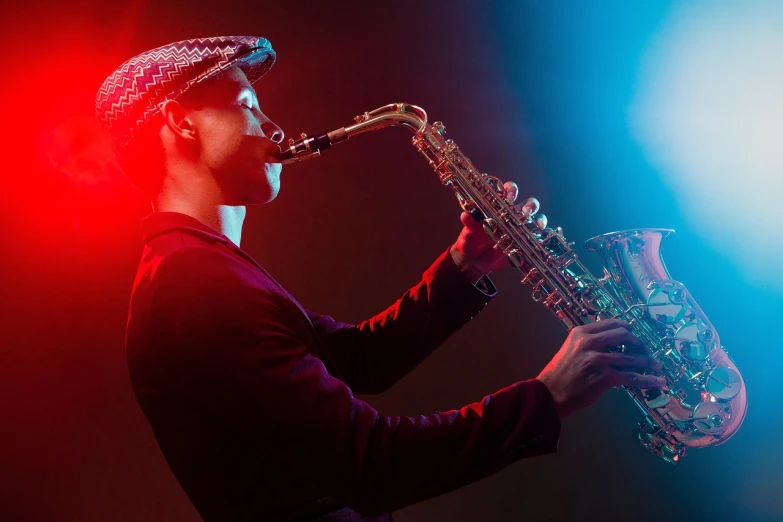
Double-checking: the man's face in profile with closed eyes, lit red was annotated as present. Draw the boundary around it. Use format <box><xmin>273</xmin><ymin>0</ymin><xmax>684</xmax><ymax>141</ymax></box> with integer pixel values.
<box><xmin>188</xmin><ymin>67</ymin><xmax>283</xmax><ymax>205</ymax></box>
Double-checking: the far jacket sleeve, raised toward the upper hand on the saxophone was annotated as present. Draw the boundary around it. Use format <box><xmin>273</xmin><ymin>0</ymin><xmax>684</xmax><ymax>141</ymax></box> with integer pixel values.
<box><xmin>308</xmin><ymin>250</ymin><xmax>497</xmax><ymax>394</ymax></box>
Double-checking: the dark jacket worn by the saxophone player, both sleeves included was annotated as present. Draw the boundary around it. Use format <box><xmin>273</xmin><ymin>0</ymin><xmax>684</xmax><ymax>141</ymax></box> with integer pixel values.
<box><xmin>126</xmin><ymin>213</ymin><xmax>560</xmax><ymax>522</ymax></box>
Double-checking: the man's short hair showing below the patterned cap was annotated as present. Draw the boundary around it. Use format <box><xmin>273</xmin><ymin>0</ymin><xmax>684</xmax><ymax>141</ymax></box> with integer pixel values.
<box><xmin>117</xmin><ymin>80</ymin><xmax>219</xmax><ymax>198</ymax></box>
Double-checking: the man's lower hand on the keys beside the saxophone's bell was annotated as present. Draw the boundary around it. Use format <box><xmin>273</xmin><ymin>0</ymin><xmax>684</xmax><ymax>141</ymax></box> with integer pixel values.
<box><xmin>537</xmin><ymin>319</ymin><xmax>666</xmax><ymax>418</ymax></box>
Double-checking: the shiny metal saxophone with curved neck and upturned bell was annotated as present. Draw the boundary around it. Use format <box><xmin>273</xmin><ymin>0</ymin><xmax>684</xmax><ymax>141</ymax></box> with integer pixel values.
<box><xmin>280</xmin><ymin>103</ymin><xmax>747</xmax><ymax>463</ymax></box>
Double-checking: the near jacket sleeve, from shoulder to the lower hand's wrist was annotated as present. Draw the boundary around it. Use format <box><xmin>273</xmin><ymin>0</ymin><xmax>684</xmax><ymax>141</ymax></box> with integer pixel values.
<box><xmin>153</xmin><ymin>250</ymin><xmax>560</xmax><ymax>515</ymax></box>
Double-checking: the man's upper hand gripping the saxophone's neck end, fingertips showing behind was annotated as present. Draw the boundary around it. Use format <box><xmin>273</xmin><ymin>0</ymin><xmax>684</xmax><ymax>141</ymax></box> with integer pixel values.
<box><xmin>451</xmin><ymin>181</ymin><xmax>538</xmax><ymax>282</ymax></box>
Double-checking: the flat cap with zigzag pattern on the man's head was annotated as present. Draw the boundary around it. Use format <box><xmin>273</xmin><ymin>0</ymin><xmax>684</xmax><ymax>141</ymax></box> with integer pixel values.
<box><xmin>95</xmin><ymin>36</ymin><xmax>276</xmax><ymax>152</ymax></box>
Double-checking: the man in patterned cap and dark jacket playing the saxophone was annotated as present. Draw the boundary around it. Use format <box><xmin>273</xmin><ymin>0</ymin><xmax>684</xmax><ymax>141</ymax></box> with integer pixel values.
<box><xmin>96</xmin><ymin>37</ymin><xmax>663</xmax><ymax>521</ymax></box>
